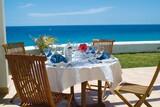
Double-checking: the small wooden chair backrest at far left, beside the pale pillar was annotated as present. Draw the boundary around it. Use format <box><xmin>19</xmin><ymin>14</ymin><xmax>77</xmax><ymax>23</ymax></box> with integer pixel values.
<box><xmin>2</xmin><ymin>42</ymin><xmax>25</xmax><ymax>54</ymax></box>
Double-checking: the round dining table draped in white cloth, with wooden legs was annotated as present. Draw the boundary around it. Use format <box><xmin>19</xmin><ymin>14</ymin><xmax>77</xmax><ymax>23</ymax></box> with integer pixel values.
<box><xmin>46</xmin><ymin>51</ymin><xmax>122</xmax><ymax>107</ymax></box>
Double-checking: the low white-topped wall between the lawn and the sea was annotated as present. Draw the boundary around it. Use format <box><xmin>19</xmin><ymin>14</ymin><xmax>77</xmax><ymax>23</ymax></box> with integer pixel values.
<box><xmin>25</xmin><ymin>41</ymin><xmax>160</xmax><ymax>54</ymax></box>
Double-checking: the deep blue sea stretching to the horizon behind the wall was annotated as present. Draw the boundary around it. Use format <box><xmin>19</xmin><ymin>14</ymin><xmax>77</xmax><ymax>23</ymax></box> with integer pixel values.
<box><xmin>6</xmin><ymin>25</ymin><xmax>160</xmax><ymax>46</ymax></box>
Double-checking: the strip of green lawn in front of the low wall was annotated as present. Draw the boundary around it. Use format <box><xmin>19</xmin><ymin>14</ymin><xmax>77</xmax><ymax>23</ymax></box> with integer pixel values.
<box><xmin>114</xmin><ymin>52</ymin><xmax>160</xmax><ymax>68</ymax></box>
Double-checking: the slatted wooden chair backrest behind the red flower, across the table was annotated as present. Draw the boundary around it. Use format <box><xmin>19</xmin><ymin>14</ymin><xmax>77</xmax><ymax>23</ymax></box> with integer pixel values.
<box><xmin>93</xmin><ymin>39</ymin><xmax>114</xmax><ymax>54</ymax></box>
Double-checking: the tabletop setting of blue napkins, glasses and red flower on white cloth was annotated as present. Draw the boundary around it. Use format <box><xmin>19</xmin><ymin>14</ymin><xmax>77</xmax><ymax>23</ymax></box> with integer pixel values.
<box><xmin>44</xmin><ymin>44</ymin><xmax>117</xmax><ymax>67</ymax></box>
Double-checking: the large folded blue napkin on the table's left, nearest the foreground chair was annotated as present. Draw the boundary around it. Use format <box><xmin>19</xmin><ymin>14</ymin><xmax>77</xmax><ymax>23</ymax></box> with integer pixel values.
<box><xmin>50</xmin><ymin>53</ymin><xmax>67</xmax><ymax>63</ymax></box>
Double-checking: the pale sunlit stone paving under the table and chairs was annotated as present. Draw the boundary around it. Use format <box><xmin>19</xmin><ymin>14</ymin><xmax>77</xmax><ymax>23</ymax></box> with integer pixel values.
<box><xmin>0</xmin><ymin>67</ymin><xmax>160</xmax><ymax>107</ymax></box>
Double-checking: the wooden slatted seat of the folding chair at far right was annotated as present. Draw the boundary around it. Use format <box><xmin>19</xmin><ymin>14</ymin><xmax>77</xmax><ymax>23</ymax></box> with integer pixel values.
<box><xmin>115</xmin><ymin>83</ymin><xmax>152</xmax><ymax>96</ymax></box>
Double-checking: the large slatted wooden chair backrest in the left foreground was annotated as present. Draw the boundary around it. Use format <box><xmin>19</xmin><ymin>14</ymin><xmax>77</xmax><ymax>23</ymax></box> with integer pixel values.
<box><xmin>6</xmin><ymin>54</ymin><xmax>55</xmax><ymax>107</ymax></box>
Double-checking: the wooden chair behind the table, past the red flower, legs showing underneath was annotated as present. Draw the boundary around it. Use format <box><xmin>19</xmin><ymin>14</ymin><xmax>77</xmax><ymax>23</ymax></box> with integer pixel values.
<box><xmin>87</xmin><ymin>39</ymin><xmax>114</xmax><ymax>98</ymax></box>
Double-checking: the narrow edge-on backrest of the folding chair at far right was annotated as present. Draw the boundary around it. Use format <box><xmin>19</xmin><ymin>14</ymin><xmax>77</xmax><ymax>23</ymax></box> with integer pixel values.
<box><xmin>146</xmin><ymin>61</ymin><xmax>160</xmax><ymax>94</ymax></box>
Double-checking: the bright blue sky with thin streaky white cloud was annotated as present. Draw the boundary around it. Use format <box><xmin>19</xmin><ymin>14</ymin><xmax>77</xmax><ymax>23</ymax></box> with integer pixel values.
<box><xmin>4</xmin><ymin>0</ymin><xmax>160</xmax><ymax>26</ymax></box>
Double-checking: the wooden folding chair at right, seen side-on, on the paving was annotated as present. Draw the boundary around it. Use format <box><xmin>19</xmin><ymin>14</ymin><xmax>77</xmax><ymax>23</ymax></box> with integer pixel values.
<box><xmin>114</xmin><ymin>62</ymin><xmax>160</xmax><ymax>107</ymax></box>
